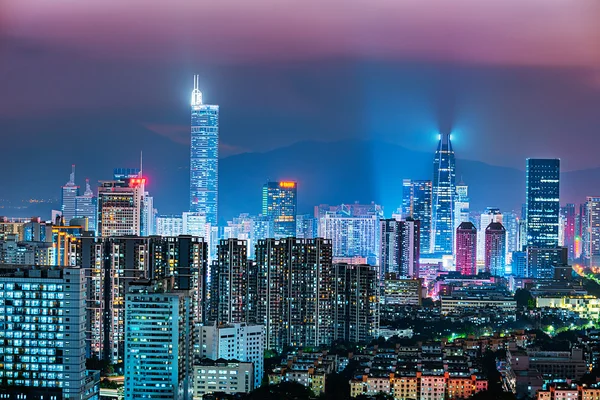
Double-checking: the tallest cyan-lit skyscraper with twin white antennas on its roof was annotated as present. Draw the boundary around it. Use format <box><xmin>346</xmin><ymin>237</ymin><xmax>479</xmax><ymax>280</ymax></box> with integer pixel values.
<box><xmin>190</xmin><ymin>75</ymin><xmax>219</xmax><ymax>226</ymax></box>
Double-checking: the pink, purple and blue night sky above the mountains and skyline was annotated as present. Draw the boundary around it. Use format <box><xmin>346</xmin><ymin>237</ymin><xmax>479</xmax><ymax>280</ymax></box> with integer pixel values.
<box><xmin>0</xmin><ymin>0</ymin><xmax>600</xmax><ymax>216</ymax></box>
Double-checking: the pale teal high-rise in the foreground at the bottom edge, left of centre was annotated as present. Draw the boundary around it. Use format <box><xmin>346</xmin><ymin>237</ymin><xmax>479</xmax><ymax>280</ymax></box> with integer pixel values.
<box><xmin>125</xmin><ymin>278</ymin><xmax>194</xmax><ymax>400</ymax></box>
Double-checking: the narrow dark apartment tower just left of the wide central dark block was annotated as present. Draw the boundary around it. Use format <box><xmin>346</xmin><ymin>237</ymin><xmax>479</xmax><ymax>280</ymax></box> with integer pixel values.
<box><xmin>207</xmin><ymin>239</ymin><xmax>250</xmax><ymax>324</ymax></box>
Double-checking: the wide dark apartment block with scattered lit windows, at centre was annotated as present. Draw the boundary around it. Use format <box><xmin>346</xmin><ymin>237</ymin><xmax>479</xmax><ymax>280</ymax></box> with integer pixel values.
<box><xmin>252</xmin><ymin>238</ymin><xmax>332</xmax><ymax>352</ymax></box>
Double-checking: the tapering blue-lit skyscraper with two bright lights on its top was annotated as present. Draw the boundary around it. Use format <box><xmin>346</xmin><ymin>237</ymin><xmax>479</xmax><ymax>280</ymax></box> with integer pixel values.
<box><xmin>431</xmin><ymin>133</ymin><xmax>456</xmax><ymax>254</ymax></box>
